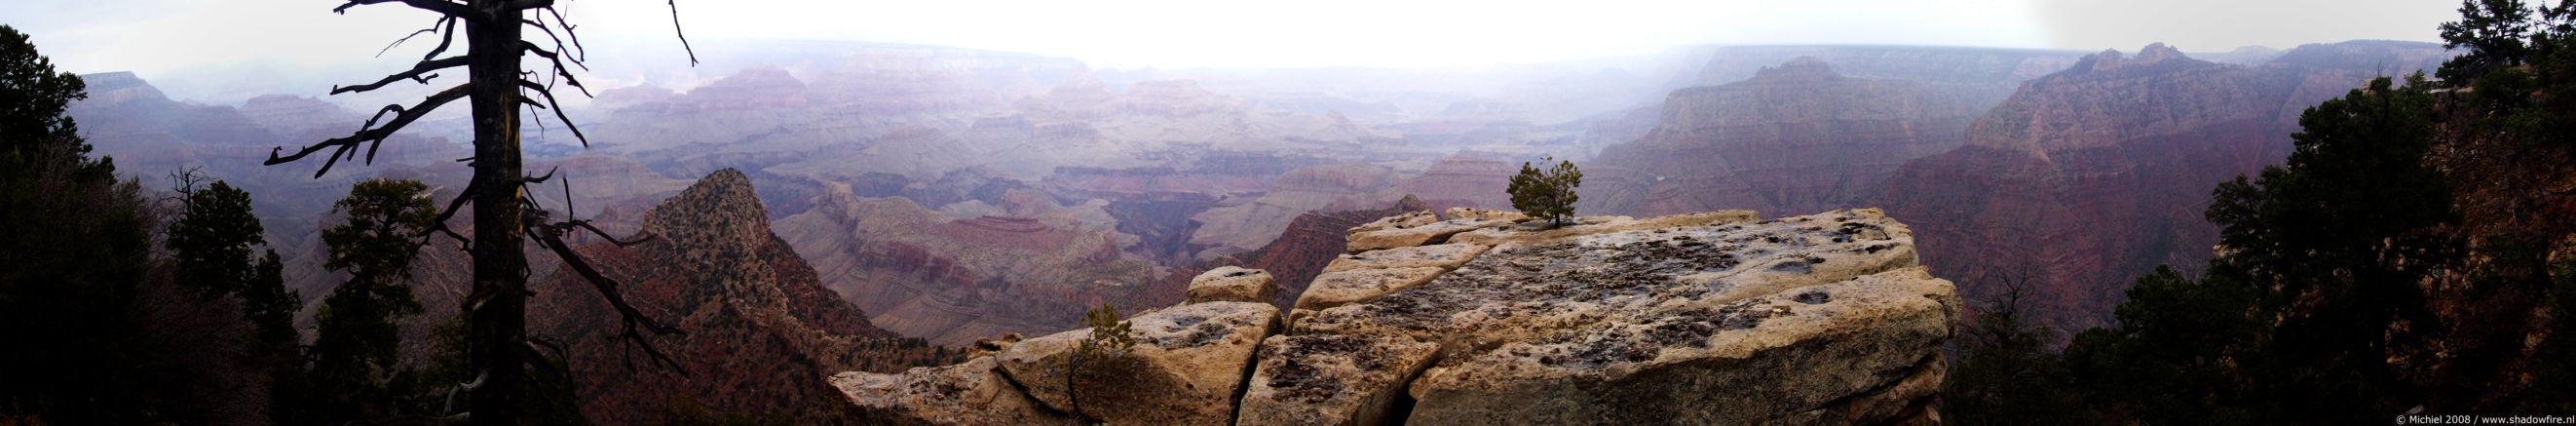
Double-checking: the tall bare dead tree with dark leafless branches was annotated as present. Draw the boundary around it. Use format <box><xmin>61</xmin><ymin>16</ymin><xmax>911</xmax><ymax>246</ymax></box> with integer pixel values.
<box><xmin>268</xmin><ymin>0</ymin><xmax>699</xmax><ymax>423</ymax></box>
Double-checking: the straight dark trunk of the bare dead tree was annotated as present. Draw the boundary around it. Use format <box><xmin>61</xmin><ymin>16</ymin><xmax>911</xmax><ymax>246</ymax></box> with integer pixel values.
<box><xmin>464</xmin><ymin>0</ymin><xmax>528</xmax><ymax>423</ymax></box>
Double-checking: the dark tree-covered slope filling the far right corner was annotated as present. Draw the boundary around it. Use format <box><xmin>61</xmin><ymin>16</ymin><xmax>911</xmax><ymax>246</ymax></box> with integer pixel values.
<box><xmin>1945</xmin><ymin>0</ymin><xmax>2576</xmax><ymax>423</ymax></box>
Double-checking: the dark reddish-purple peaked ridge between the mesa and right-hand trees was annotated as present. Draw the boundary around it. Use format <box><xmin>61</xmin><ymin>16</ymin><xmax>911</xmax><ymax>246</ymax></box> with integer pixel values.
<box><xmin>1868</xmin><ymin>41</ymin><xmax>2443</xmax><ymax>330</ymax></box>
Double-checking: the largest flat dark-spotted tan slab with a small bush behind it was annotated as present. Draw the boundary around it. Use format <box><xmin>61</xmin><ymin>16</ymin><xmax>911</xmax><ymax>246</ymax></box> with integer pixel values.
<box><xmin>1298</xmin><ymin>210</ymin><xmax>1957</xmax><ymax>423</ymax></box>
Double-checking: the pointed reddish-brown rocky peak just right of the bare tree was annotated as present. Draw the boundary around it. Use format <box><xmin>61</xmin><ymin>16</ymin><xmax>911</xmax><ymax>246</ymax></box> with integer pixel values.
<box><xmin>528</xmin><ymin>171</ymin><xmax>956</xmax><ymax>423</ymax></box>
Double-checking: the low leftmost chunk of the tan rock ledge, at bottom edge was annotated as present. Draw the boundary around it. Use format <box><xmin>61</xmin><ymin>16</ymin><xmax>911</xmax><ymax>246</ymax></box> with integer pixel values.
<box><xmin>832</xmin><ymin>356</ymin><xmax>1067</xmax><ymax>423</ymax></box>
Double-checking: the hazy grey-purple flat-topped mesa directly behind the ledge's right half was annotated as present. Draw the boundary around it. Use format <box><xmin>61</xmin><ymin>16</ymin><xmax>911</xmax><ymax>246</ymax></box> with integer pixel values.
<box><xmin>1581</xmin><ymin>57</ymin><xmax>2009</xmax><ymax>214</ymax></box>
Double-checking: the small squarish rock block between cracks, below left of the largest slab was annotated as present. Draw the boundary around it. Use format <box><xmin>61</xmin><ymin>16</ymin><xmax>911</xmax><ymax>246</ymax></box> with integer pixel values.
<box><xmin>1236</xmin><ymin>335</ymin><xmax>1440</xmax><ymax>426</ymax></box>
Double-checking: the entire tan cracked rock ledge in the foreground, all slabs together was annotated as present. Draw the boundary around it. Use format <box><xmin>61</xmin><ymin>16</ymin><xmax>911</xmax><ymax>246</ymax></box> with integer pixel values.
<box><xmin>832</xmin><ymin>210</ymin><xmax>1960</xmax><ymax>423</ymax></box>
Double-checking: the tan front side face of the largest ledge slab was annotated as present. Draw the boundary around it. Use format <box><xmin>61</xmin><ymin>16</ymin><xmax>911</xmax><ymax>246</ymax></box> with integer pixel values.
<box><xmin>1412</xmin><ymin>268</ymin><xmax>1957</xmax><ymax>423</ymax></box>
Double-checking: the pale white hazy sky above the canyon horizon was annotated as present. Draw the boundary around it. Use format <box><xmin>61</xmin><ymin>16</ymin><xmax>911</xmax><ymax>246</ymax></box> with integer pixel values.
<box><xmin>0</xmin><ymin>0</ymin><xmax>2457</xmax><ymax>77</ymax></box>
